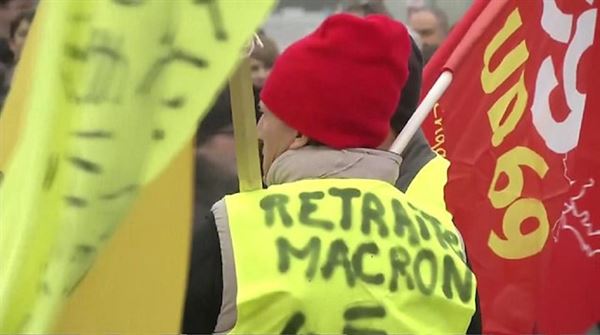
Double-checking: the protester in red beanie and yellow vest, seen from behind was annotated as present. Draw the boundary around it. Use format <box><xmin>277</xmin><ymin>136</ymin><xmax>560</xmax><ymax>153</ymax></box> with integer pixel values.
<box><xmin>182</xmin><ymin>14</ymin><xmax>475</xmax><ymax>333</ymax></box>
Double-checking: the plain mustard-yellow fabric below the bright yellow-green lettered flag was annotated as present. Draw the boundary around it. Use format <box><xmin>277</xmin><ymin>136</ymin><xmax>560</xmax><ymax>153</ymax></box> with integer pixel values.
<box><xmin>55</xmin><ymin>145</ymin><xmax>194</xmax><ymax>335</ymax></box>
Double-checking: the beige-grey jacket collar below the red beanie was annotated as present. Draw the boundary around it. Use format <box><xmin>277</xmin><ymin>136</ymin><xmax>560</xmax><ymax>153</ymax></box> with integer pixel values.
<box><xmin>265</xmin><ymin>145</ymin><xmax>402</xmax><ymax>186</ymax></box>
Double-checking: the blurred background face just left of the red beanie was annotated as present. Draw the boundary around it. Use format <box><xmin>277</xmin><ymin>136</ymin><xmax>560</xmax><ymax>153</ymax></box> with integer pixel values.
<box><xmin>250</xmin><ymin>30</ymin><xmax>279</xmax><ymax>91</ymax></box>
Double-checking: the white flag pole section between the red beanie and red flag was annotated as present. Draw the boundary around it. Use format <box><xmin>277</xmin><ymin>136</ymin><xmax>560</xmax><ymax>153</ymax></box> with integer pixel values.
<box><xmin>389</xmin><ymin>71</ymin><xmax>452</xmax><ymax>155</ymax></box>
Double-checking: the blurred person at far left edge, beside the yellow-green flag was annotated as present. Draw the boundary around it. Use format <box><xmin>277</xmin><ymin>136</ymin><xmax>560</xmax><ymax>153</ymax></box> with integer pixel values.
<box><xmin>0</xmin><ymin>11</ymin><xmax>35</xmax><ymax>105</ymax></box>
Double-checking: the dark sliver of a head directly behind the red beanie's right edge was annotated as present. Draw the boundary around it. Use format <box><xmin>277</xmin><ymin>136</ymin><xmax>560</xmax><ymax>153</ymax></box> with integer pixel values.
<box><xmin>390</xmin><ymin>37</ymin><xmax>423</xmax><ymax>133</ymax></box>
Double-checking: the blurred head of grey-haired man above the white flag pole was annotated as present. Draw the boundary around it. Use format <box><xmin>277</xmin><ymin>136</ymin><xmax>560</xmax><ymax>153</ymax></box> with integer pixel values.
<box><xmin>408</xmin><ymin>7</ymin><xmax>449</xmax><ymax>64</ymax></box>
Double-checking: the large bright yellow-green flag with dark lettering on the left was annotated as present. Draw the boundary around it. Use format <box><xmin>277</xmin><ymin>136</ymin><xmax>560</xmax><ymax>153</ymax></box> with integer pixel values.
<box><xmin>0</xmin><ymin>0</ymin><xmax>273</xmax><ymax>333</ymax></box>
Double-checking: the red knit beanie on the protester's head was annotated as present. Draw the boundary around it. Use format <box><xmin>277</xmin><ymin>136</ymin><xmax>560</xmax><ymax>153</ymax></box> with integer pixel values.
<box><xmin>261</xmin><ymin>14</ymin><xmax>411</xmax><ymax>149</ymax></box>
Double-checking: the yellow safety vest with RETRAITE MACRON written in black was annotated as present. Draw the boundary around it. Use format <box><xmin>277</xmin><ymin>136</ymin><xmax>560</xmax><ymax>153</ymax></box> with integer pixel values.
<box><xmin>225</xmin><ymin>179</ymin><xmax>476</xmax><ymax>334</ymax></box>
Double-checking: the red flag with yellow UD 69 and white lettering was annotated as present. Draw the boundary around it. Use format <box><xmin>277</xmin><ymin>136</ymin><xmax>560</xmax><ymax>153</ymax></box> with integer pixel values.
<box><xmin>423</xmin><ymin>0</ymin><xmax>600</xmax><ymax>334</ymax></box>
